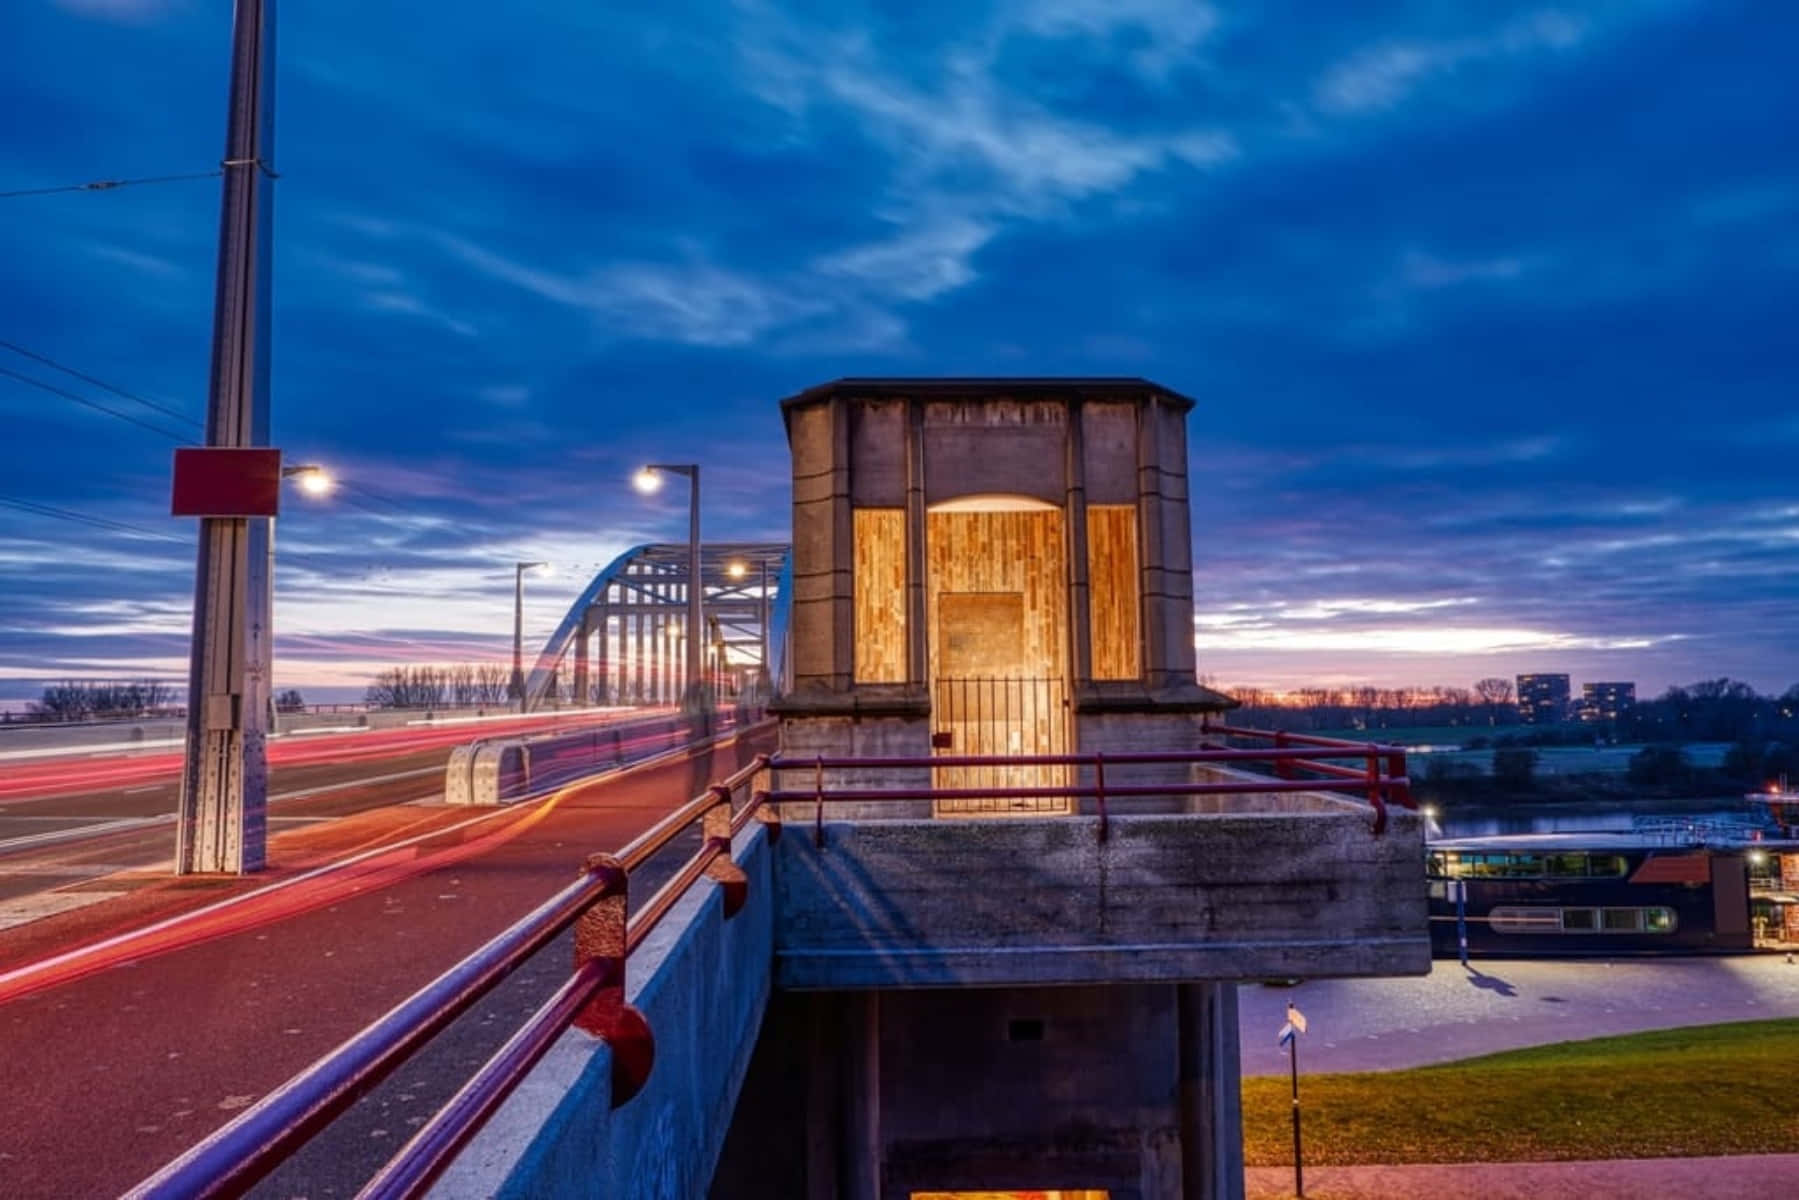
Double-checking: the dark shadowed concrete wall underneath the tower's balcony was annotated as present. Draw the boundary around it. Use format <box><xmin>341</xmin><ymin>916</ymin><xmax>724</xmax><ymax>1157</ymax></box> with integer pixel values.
<box><xmin>712</xmin><ymin>984</ymin><xmax>1243</xmax><ymax>1200</ymax></box>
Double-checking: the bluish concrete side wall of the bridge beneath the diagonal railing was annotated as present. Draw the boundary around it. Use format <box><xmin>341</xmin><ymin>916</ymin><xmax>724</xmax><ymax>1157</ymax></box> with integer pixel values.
<box><xmin>430</xmin><ymin>824</ymin><xmax>774</xmax><ymax>1200</ymax></box>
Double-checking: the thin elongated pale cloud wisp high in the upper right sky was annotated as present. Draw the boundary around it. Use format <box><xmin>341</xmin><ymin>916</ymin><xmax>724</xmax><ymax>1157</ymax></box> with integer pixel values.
<box><xmin>1311</xmin><ymin>9</ymin><xmax>1589</xmax><ymax>117</ymax></box>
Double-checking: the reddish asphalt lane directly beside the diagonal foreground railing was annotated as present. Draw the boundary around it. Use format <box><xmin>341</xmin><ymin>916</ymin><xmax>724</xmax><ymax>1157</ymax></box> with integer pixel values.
<box><xmin>0</xmin><ymin>734</ymin><xmax>772</xmax><ymax>1196</ymax></box>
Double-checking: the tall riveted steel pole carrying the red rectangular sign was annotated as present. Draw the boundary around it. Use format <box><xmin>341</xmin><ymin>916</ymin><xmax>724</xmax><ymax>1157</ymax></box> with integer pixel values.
<box><xmin>175</xmin><ymin>0</ymin><xmax>279</xmax><ymax>874</ymax></box>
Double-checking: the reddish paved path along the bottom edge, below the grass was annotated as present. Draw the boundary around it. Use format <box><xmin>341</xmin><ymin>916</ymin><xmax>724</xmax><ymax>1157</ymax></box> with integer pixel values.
<box><xmin>1247</xmin><ymin>1155</ymin><xmax>1799</xmax><ymax>1200</ymax></box>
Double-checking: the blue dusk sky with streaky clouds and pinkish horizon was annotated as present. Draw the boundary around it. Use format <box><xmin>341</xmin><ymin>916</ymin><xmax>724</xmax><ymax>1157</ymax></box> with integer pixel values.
<box><xmin>0</xmin><ymin>0</ymin><xmax>1799</xmax><ymax>698</ymax></box>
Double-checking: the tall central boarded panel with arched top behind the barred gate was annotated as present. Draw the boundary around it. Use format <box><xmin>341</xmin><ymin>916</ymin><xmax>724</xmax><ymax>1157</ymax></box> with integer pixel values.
<box><xmin>925</xmin><ymin>509</ymin><xmax>1072</xmax><ymax>815</ymax></box>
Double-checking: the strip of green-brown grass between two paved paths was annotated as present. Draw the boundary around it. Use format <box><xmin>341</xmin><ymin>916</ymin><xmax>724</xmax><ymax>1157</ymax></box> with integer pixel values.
<box><xmin>1243</xmin><ymin>1020</ymin><xmax>1799</xmax><ymax>1166</ymax></box>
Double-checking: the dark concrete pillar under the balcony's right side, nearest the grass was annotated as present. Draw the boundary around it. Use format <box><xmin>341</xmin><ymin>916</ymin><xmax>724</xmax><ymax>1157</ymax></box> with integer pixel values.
<box><xmin>1175</xmin><ymin>982</ymin><xmax>1243</xmax><ymax>1200</ymax></box>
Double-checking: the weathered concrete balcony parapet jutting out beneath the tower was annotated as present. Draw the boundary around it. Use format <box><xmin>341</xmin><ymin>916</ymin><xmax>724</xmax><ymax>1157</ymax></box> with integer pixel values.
<box><xmin>775</xmin><ymin>813</ymin><xmax>1430</xmax><ymax>988</ymax></box>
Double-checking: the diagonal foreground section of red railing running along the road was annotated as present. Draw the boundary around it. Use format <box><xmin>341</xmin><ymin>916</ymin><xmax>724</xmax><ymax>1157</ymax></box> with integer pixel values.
<box><xmin>128</xmin><ymin>723</ymin><xmax>768</xmax><ymax>1200</ymax></box>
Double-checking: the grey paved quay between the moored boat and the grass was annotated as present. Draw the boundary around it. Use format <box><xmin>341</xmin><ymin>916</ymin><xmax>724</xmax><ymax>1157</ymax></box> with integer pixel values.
<box><xmin>1238</xmin><ymin>955</ymin><xmax>1799</xmax><ymax>1079</ymax></box>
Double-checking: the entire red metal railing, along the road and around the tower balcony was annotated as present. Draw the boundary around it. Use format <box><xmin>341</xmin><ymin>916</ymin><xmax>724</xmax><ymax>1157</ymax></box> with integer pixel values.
<box><xmin>128</xmin><ymin>725</ymin><xmax>1416</xmax><ymax>1200</ymax></box>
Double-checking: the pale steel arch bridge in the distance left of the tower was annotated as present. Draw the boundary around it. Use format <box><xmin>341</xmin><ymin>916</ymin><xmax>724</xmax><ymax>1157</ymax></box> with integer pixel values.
<box><xmin>522</xmin><ymin>542</ymin><xmax>793</xmax><ymax>712</ymax></box>
